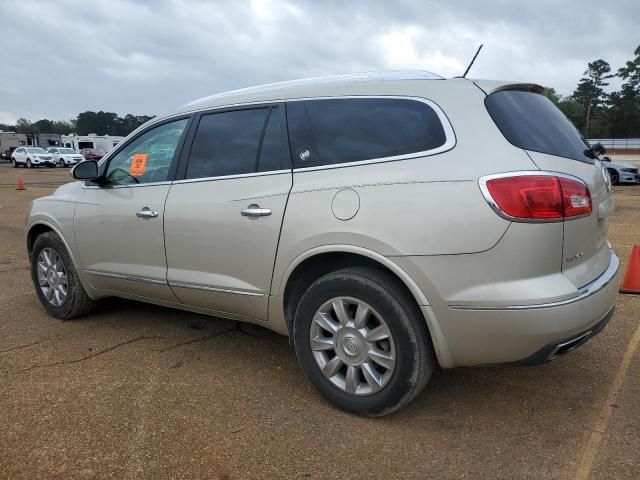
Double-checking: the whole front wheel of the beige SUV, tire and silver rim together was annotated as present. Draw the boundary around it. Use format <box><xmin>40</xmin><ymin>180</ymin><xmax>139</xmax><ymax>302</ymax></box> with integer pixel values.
<box><xmin>31</xmin><ymin>232</ymin><xmax>95</xmax><ymax>320</ymax></box>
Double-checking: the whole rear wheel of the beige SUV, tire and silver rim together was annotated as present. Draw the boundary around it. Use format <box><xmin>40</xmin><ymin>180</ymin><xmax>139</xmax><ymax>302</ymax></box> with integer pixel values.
<box><xmin>293</xmin><ymin>267</ymin><xmax>435</xmax><ymax>417</ymax></box>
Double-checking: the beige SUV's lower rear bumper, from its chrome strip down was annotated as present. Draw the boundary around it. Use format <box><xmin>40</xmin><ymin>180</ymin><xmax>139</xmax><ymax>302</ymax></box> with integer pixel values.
<box><xmin>439</xmin><ymin>252</ymin><xmax>620</xmax><ymax>366</ymax></box>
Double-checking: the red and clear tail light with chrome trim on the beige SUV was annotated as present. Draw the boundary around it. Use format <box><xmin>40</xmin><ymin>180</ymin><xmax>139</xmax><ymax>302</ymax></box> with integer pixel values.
<box><xmin>480</xmin><ymin>172</ymin><xmax>592</xmax><ymax>222</ymax></box>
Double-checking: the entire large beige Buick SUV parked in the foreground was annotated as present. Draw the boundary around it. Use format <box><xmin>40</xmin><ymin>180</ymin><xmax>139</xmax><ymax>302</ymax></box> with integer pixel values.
<box><xmin>27</xmin><ymin>72</ymin><xmax>619</xmax><ymax>416</ymax></box>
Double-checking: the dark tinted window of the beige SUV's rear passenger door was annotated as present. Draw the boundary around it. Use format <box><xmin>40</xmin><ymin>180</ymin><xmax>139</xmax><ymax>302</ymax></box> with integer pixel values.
<box><xmin>186</xmin><ymin>107</ymin><xmax>286</xmax><ymax>179</ymax></box>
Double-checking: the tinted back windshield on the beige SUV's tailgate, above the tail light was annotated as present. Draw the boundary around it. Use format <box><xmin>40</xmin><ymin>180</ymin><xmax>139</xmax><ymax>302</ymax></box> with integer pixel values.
<box><xmin>485</xmin><ymin>90</ymin><xmax>593</xmax><ymax>163</ymax></box>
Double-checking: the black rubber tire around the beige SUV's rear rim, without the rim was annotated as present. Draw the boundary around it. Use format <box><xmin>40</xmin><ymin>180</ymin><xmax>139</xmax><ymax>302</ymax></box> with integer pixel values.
<box><xmin>293</xmin><ymin>267</ymin><xmax>435</xmax><ymax>417</ymax></box>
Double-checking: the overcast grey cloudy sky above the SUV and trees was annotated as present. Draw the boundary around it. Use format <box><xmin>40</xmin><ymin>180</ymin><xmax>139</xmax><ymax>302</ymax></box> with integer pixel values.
<box><xmin>0</xmin><ymin>0</ymin><xmax>640</xmax><ymax>123</ymax></box>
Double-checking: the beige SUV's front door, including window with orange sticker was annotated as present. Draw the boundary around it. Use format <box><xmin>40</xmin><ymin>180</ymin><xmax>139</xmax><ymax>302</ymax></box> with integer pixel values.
<box><xmin>74</xmin><ymin>117</ymin><xmax>190</xmax><ymax>302</ymax></box>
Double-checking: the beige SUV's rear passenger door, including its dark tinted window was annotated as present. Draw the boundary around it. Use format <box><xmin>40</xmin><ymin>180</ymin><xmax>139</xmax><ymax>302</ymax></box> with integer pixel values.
<box><xmin>165</xmin><ymin>104</ymin><xmax>292</xmax><ymax>320</ymax></box>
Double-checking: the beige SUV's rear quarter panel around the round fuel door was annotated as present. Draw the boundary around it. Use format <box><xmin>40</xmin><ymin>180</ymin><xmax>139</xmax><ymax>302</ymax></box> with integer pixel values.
<box><xmin>272</xmin><ymin>80</ymin><xmax>536</xmax><ymax>296</ymax></box>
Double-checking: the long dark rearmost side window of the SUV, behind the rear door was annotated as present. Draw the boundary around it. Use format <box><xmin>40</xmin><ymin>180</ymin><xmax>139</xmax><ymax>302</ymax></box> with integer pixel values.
<box><xmin>287</xmin><ymin>98</ymin><xmax>447</xmax><ymax>168</ymax></box>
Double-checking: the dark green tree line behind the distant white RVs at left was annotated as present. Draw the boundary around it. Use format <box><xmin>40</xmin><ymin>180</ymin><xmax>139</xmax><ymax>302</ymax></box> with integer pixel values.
<box><xmin>0</xmin><ymin>111</ymin><xmax>153</xmax><ymax>137</ymax></box>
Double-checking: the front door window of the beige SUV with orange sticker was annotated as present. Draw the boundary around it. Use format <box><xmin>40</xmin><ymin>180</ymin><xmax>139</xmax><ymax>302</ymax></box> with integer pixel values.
<box><xmin>105</xmin><ymin>118</ymin><xmax>189</xmax><ymax>186</ymax></box>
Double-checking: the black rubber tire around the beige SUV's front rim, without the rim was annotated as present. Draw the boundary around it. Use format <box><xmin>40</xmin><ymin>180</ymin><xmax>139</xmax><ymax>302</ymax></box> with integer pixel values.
<box><xmin>31</xmin><ymin>232</ymin><xmax>95</xmax><ymax>320</ymax></box>
